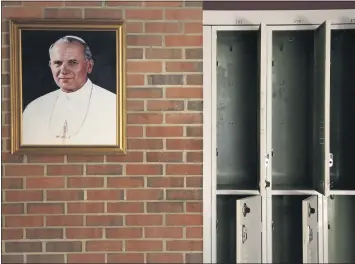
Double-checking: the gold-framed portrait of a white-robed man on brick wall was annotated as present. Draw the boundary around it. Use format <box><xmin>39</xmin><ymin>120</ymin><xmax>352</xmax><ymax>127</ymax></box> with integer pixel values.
<box><xmin>10</xmin><ymin>20</ymin><xmax>126</xmax><ymax>154</ymax></box>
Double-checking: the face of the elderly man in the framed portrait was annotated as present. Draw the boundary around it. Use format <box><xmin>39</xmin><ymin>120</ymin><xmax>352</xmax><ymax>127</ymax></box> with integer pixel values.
<box><xmin>50</xmin><ymin>40</ymin><xmax>93</xmax><ymax>93</ymax></box>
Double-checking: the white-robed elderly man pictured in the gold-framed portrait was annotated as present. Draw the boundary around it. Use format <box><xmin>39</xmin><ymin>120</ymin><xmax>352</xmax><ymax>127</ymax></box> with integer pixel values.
<box><xmin>22</xmin><ymin>36</ymin><xmax>117</xmax><ymax>145</ymax></box>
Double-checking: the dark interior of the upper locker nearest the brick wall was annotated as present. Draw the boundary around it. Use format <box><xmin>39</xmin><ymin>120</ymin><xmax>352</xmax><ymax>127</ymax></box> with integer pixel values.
<box><xmin>217</xmin><ymin>31</ymin><xmax>259</xmax><ymax>189</ymax></box>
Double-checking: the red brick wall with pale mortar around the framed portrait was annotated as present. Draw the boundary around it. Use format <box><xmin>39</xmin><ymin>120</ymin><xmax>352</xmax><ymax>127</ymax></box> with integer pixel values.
<box><xmin>2</xmin><ymin>1</ymin><xmax>202</xmax><ymax>263</ymax></box>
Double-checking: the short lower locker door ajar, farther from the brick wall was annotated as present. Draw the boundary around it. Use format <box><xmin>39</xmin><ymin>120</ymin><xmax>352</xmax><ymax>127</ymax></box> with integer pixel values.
<box><xmin>302</xmin><ymin>196</ymin><xmax>322</xmax><ymax>263</ymax></box>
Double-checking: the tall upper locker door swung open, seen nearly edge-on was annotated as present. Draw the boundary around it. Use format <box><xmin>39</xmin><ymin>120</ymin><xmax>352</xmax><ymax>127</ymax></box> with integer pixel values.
<box><xmin>313</xmin><ymin>21</ymin><xmax>331</xmax><ymax>195</ymax></box>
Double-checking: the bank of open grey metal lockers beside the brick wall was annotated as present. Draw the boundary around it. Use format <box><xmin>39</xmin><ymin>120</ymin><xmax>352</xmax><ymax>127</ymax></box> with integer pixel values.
<box><xmin>204</xmin><ymin>10</ymin><xmax>355</xmax><ymax>263</ymax></box>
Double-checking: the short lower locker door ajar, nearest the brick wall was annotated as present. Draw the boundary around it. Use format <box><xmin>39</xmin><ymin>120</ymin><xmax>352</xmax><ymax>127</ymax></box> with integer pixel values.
<box><xmin>236</xmin><ymin>196</ymin><xmax>262</xmax><ymax>263</ymax></box>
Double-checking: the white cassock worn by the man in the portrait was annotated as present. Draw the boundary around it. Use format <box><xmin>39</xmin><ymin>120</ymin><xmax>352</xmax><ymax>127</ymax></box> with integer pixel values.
<box><xmin>22</xmin><ymin>79</ymin><xmax>117</xmax><ymax>145</ymax></box>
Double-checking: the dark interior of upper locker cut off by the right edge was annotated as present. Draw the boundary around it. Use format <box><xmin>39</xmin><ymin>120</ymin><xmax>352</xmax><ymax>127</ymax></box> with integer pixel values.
<box><xmin>330</xmin><ymin>29</ymin><xmax>355</xmax><ymax>190</ymax></box>
